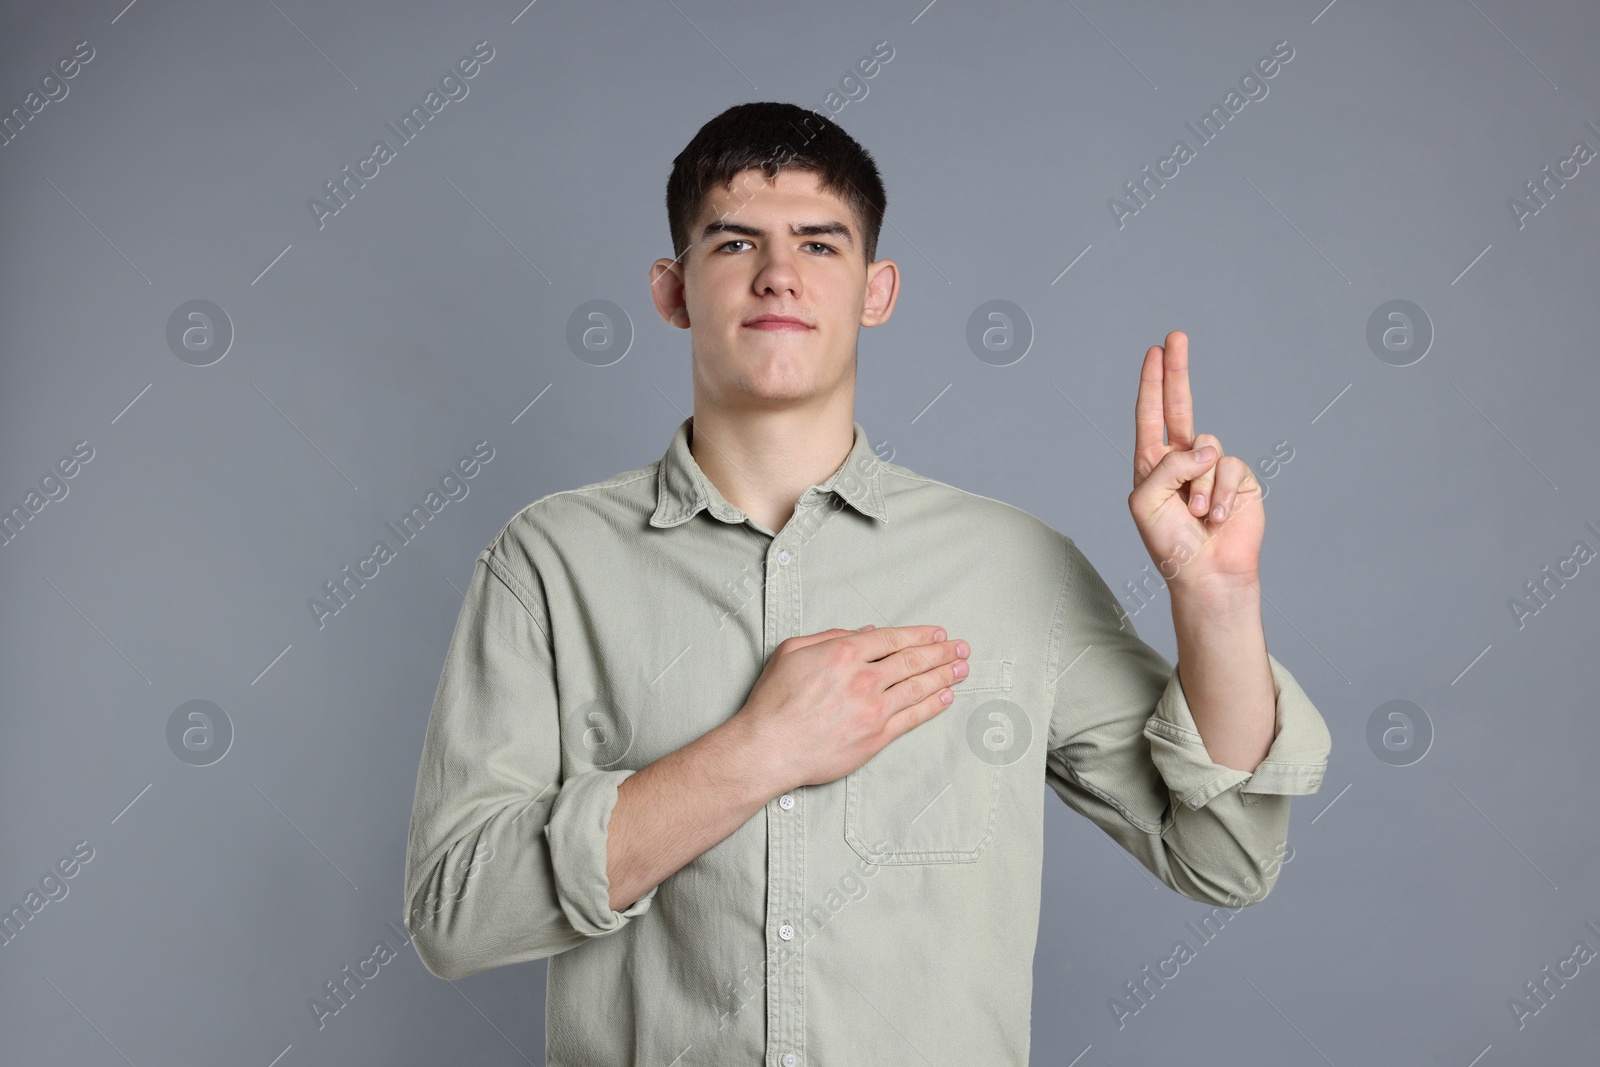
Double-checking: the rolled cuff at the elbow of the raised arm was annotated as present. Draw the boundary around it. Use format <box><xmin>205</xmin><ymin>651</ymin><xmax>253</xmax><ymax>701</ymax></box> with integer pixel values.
<box><xmin>1144</xmin><ymin>653</ymin><xmax>1333</xmax><ymax>808</ymax></box>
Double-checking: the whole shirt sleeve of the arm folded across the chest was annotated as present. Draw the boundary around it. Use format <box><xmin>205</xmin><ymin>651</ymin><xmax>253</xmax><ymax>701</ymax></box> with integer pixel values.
<box><xmin>405</xmin><ymin>545</ymin><xmax>659</xmax><ymax>979</ymax></box>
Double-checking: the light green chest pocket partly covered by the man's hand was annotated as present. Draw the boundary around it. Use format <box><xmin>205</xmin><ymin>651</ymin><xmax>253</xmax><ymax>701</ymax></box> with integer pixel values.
<box><xmin>845</xmin><ymin>659</ymin><xmax>1011</xmax><ymax>864</ymax></box>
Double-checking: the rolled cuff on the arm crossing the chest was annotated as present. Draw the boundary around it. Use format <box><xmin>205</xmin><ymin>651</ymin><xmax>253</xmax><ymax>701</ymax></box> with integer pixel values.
<box><xmin>544</xmin><ymin>769</ymin><xmax>661</xmax><ymax>937</ymax></box>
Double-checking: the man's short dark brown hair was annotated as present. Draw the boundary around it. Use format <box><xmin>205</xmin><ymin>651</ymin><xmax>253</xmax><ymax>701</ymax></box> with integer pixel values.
<box><xmin>667</xmin><ymin>101</ymin><xmax>888</xmax><ymax>262</ymax></box>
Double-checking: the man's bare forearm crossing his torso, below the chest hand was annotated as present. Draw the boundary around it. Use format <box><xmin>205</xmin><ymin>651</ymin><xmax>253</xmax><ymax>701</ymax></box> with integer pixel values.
<box><xmin>606</xmin><ymin>717</ymin><xmax>786</xmax><ymax>910</ymax></box>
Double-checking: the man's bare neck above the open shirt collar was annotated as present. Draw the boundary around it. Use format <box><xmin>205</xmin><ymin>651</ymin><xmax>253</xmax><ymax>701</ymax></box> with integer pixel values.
<box><xmin>690</xmin><ymin>405</ymin><xmax>856</xmax><ymax>533</ymax></box>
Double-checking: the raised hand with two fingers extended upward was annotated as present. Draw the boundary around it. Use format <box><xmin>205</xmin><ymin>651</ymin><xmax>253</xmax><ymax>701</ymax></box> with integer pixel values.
<box><xmin>1128</xmin><ymin>330</ymin><xmax>1267</xmax><ymax>589</ymax></box>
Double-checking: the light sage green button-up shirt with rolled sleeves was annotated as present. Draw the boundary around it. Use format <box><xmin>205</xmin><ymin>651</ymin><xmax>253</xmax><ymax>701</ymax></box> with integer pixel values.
<box><xmin>405</xmin><ymin>416</ymin><xmax>1330</xmax><ymax>1067</ymax></box>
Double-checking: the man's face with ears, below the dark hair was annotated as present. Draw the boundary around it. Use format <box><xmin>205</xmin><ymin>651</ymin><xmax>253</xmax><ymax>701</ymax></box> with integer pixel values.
<box><xmin>651</xmin><ymin>168</ymin><xmax>898</xmax><ymax>408</ymax></box>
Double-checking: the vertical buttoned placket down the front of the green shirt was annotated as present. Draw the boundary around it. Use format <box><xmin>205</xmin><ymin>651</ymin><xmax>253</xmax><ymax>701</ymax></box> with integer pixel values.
<box><xmin>763</xmin><ymin>502</ymin><xmax>806</xmax><ymax>1067</ymax></box>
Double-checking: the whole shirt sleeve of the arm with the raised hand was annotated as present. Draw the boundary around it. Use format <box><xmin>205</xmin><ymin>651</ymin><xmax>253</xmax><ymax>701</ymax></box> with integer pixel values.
<box><xmin>1045</xmin><ymin>537</ymin><xmax>1331</xmax><ymax>907</ymax></box>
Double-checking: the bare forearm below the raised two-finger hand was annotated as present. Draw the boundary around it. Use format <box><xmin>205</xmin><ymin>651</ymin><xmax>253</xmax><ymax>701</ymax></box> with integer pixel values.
<box><xmin>1170</xmin><ymin>582</ymin><xmax>1277</xmax><ymax>771</ymax></box>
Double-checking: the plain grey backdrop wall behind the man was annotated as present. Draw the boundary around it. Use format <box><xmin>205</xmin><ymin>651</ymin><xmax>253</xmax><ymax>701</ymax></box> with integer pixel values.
<box><xmin>0</xmin><ymin>0</ymin><xmax>1600</xmax><ymax>1067</ymax></box>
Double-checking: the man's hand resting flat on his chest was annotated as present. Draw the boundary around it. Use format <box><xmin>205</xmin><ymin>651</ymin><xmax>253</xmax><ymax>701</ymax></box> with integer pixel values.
<box><xmin>730</xmin><ymin>625</ymin><xmax>971</xmax><ymax>789</ymax></box>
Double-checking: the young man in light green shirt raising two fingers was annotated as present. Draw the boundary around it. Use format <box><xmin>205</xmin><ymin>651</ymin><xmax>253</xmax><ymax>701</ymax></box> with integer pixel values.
<box><xmin>405</xmin><ymin>104</ymin><xmax>1330</xmax><ymax>1067</ymax></box>
